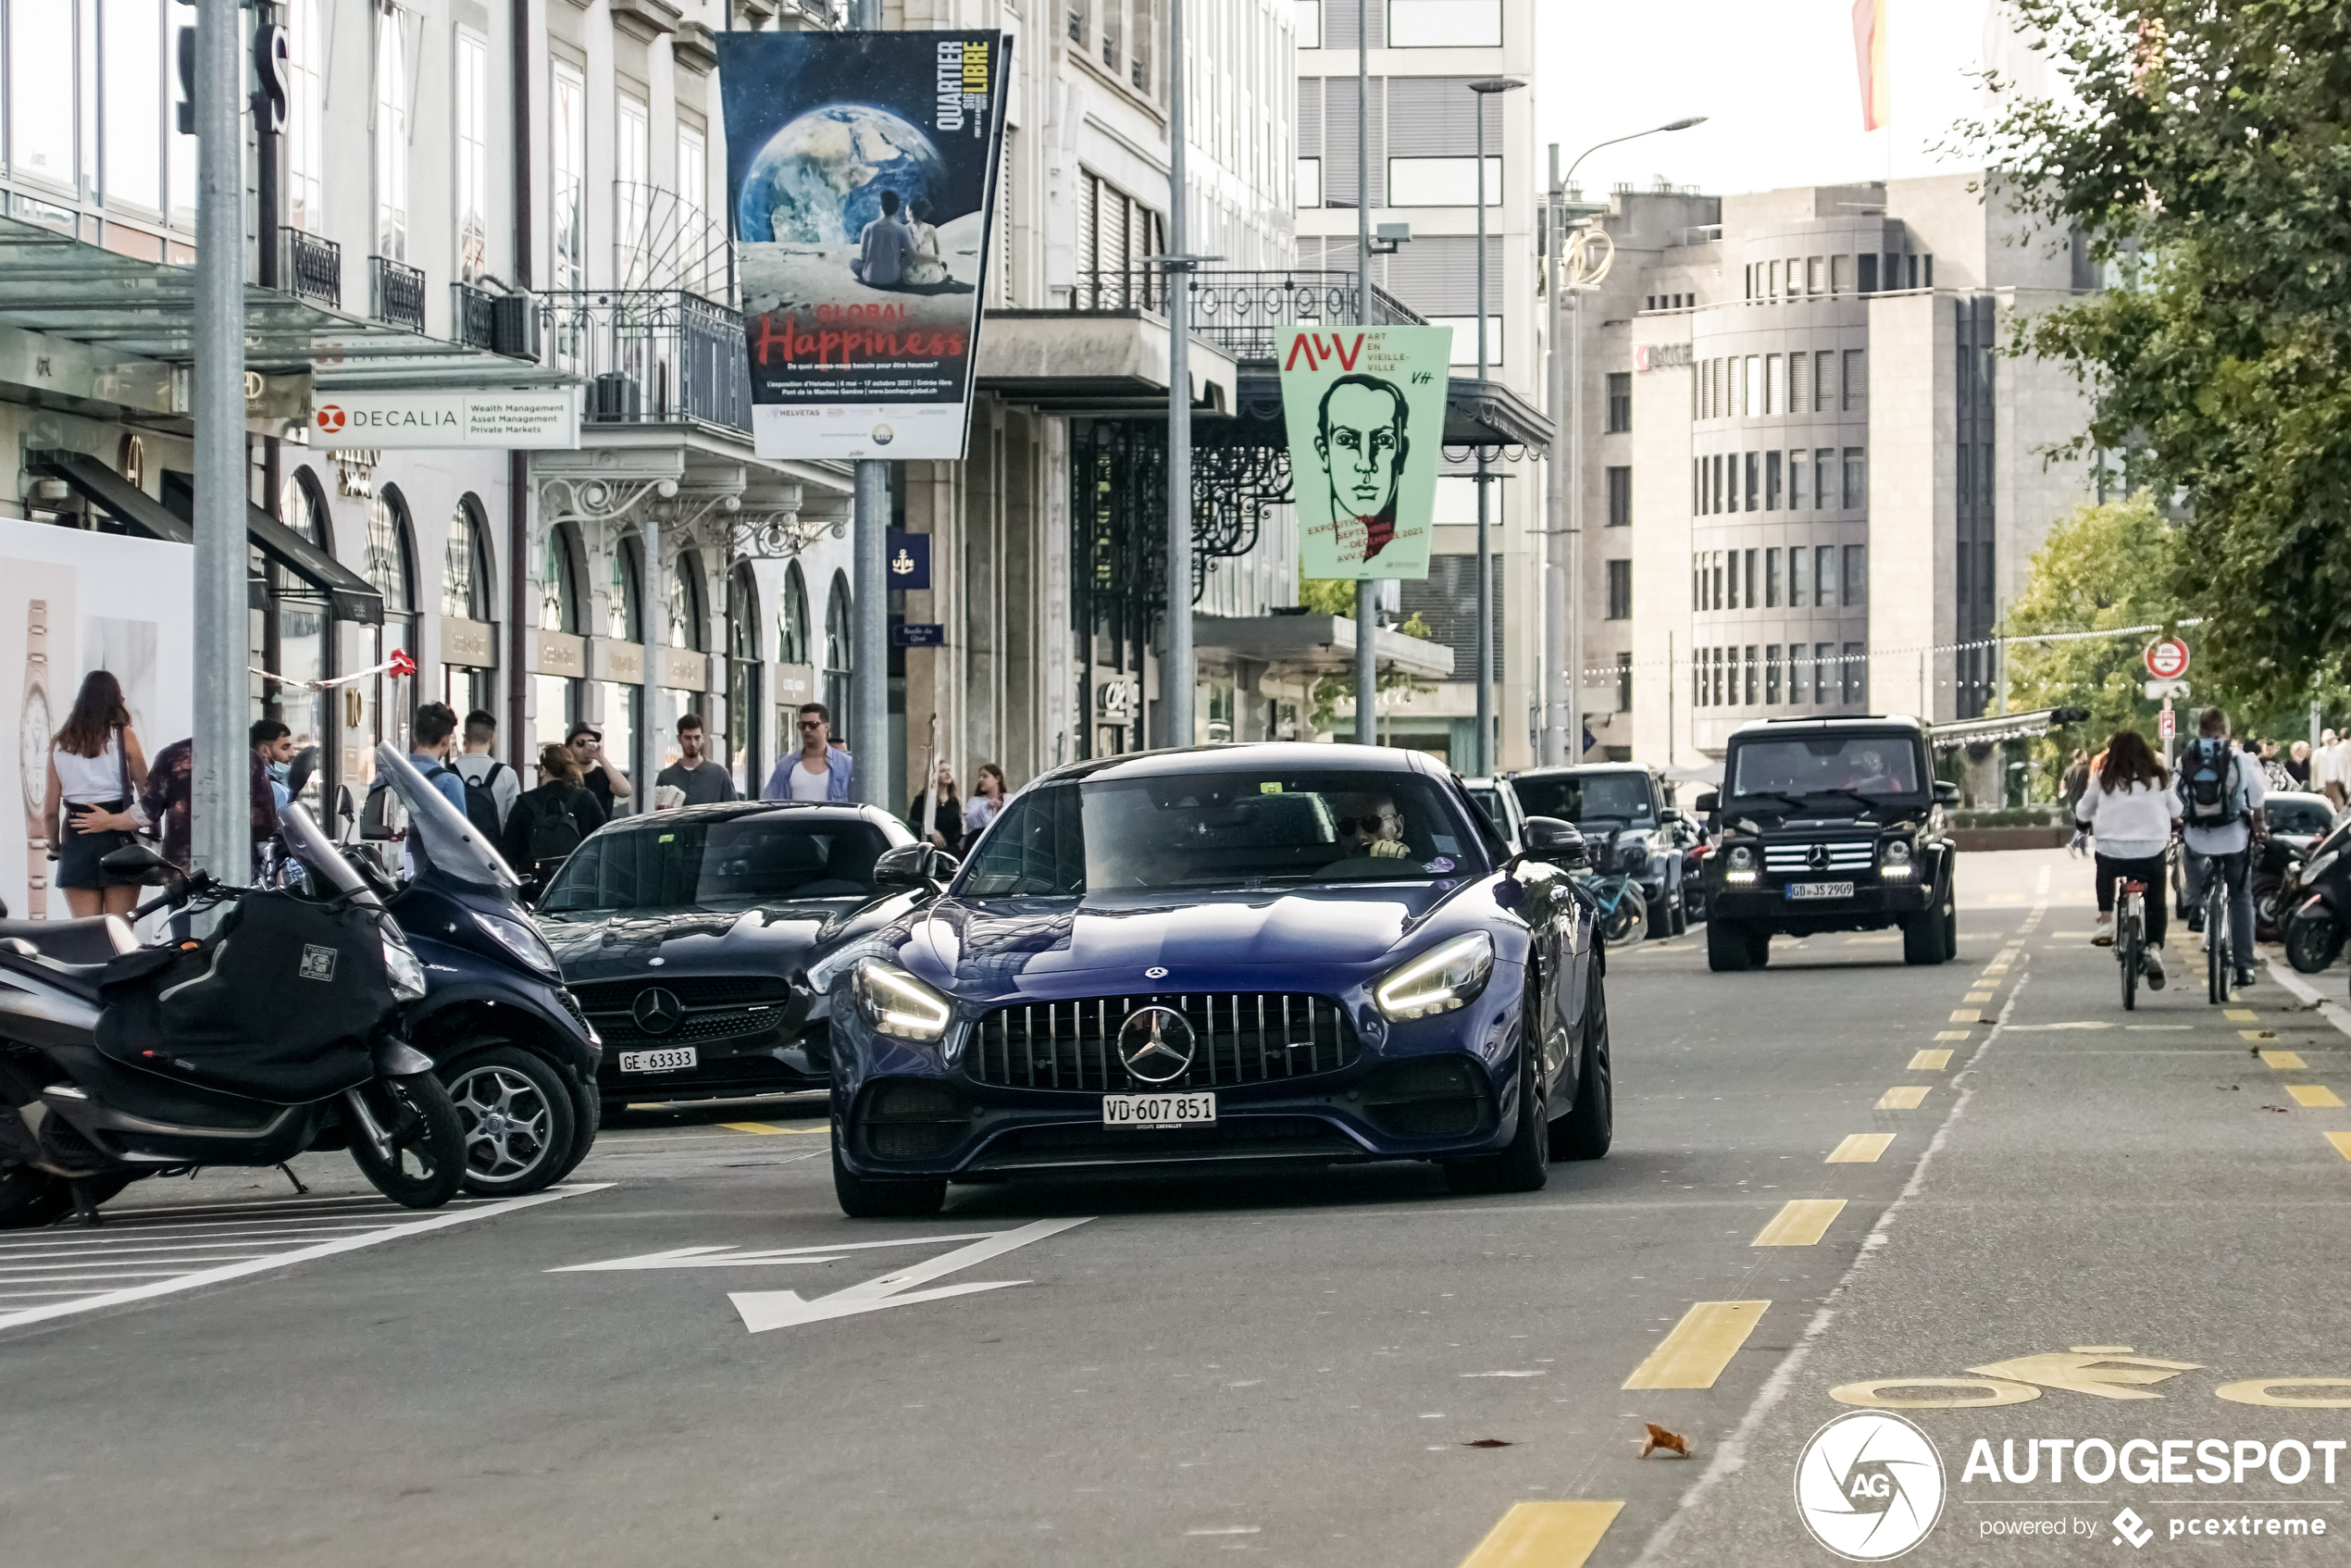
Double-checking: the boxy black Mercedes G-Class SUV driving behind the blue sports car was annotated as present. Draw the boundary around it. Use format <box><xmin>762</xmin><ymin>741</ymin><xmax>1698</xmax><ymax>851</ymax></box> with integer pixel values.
<box><xmin>1698</xmin><ymin>717</ymin><xmax>1959</xmax><ymax>973</ymax></box>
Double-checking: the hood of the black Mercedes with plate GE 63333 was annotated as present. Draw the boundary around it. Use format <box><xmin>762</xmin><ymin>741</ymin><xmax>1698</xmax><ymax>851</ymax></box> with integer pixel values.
<box><xmin>539</xmin><ymin>898</ymin><xmax>901</xmax><ymax>985</ymax></box>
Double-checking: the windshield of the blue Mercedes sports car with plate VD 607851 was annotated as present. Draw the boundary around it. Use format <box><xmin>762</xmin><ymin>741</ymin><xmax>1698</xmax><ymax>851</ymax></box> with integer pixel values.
<box><xmin>954</xmin><ymin>768</ymin><xmax>1486</xmax><ymax>898</ymax></box>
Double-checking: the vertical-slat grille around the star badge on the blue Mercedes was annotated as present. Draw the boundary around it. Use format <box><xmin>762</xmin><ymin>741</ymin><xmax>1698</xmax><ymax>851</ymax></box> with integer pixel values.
<box><xmin>964</xmin><ymin>992</ymin><xmax>1362</xmax><ymax>1093</ymax></box>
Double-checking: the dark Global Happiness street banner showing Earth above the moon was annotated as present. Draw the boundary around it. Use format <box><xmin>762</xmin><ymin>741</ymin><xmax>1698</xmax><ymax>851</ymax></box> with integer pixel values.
<box><xmin>717</xmin><ymin>33</ymin><xmax>1011</xmax><ymax>461</ymax></box>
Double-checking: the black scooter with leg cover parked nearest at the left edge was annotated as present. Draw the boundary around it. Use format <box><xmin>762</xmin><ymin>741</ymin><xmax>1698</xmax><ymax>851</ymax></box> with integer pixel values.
<box><xmin>0</xmin><ymin>806</ymin><xmax>466</xmax><ymax>1229</ymax></box>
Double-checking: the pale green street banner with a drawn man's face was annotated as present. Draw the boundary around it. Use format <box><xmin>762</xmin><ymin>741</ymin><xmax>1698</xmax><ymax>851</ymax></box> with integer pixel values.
<box><xmin>1276</xmin><ymin>327</ymin><xmax>1453</xmax><ymax>579</ymax></box>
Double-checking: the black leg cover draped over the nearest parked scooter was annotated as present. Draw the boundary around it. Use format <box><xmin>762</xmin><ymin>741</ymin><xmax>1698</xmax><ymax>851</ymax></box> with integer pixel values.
<box><xmin>96</xmin><ymin>891</ymin><xmax>397</xmax><ymax>1105</ymax></box>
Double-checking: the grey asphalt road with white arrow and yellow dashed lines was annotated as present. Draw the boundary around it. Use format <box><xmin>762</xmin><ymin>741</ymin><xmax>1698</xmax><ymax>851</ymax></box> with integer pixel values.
<box><xmin>0</xmin><ymin>853</ymin><xmax>2351</xmax><ymax>1568</ymax></box>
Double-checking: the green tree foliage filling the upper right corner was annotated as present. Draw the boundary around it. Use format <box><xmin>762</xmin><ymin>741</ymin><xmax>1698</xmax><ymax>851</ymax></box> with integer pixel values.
<box><xmin>1963</xmin><ymin>0</ymin><xmax>2351</xmax><ymax>701</ymax></box>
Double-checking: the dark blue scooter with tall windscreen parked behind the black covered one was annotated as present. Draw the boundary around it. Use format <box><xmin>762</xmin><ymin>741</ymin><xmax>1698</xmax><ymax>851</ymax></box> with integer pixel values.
<box><xmin>353</xmin><ymin>745</ymin><xmax>604</xmax><ymax>1197</ymax></box>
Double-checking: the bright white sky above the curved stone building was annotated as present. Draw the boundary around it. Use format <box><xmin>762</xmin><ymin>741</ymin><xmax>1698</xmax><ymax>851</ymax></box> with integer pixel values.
<box><xmin>1533</xmin><ymin>0</ymin><xmax>1986</xmax><ymax>197</ymax></box>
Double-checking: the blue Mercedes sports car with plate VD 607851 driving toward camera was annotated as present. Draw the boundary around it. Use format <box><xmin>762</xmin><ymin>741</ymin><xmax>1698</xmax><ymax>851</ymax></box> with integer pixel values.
<box><xmin>809</xmin><ymin>745</ymin><xmax>1611</xmax><ymax>1215</ymax></box>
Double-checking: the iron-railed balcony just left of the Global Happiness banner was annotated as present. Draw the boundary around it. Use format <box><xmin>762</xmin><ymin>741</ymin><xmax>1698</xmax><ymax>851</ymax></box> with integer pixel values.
<box><xmin>536</xmin><ymin>289</ymin><xmax>750</xmax><ymax>435</ymax></box>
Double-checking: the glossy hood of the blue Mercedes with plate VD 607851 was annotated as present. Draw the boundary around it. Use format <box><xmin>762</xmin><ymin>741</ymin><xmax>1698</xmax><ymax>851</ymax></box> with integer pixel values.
<box><xmin>902</xmin><ymin>879</ymin><xmax>1474</xmax><ymax>994</ymax></box>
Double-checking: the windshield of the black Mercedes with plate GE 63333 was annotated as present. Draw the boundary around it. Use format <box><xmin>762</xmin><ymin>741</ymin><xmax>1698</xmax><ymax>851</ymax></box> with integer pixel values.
<box><xmin>539</xmin><ymin>815</ymin><xmax>889</xmax><ymax>915</ymax></box>
